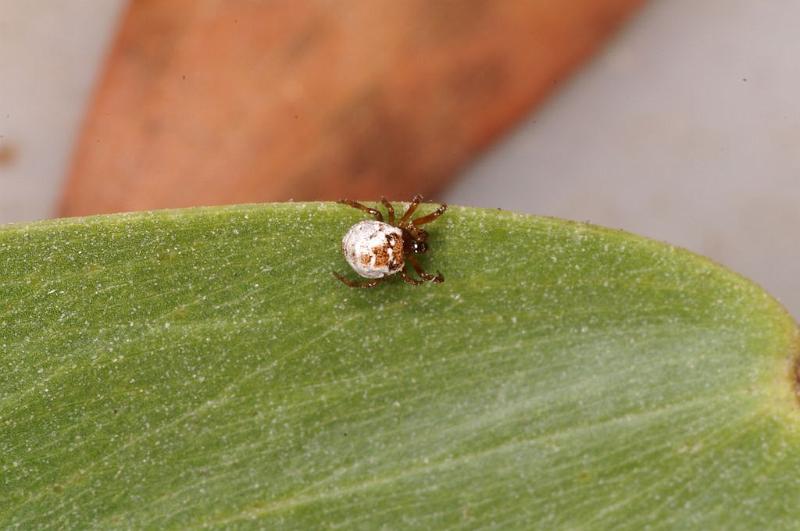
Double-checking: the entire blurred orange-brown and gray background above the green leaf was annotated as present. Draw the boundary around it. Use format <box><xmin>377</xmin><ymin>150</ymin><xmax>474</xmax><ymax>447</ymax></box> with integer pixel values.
<box><xmin>0</xmin><ymin>0</ymin><xmax>800</xmax><ymax>316</ymax></box>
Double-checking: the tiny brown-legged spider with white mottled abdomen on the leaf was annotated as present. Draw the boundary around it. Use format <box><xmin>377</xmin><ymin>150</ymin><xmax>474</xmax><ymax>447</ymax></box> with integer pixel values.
<box><xmin>333</xmin><ymin>195</ymin><xmax>447</xmax><ymax>288</ymax></box>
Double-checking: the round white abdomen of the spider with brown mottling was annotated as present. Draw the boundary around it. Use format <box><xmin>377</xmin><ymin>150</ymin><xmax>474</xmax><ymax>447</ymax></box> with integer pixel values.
<box><xmin>342</xmin><ymin>221</ymin><xmax>403</xmax><ymax>278</ymax></box>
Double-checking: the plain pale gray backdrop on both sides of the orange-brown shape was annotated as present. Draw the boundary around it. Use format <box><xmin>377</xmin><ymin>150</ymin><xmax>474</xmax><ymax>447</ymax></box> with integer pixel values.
<box><xmin>0</xmin><ymin>0</ymin><xmax>800</xmax><ymax>316</ymax></box>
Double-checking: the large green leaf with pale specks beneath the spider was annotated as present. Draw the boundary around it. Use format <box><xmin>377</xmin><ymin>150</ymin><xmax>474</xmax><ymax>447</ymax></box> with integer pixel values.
<box><xmin>0</xmin><ymin>204</ymin><xmax>800</xmax><ymax>529</ymax></box>
